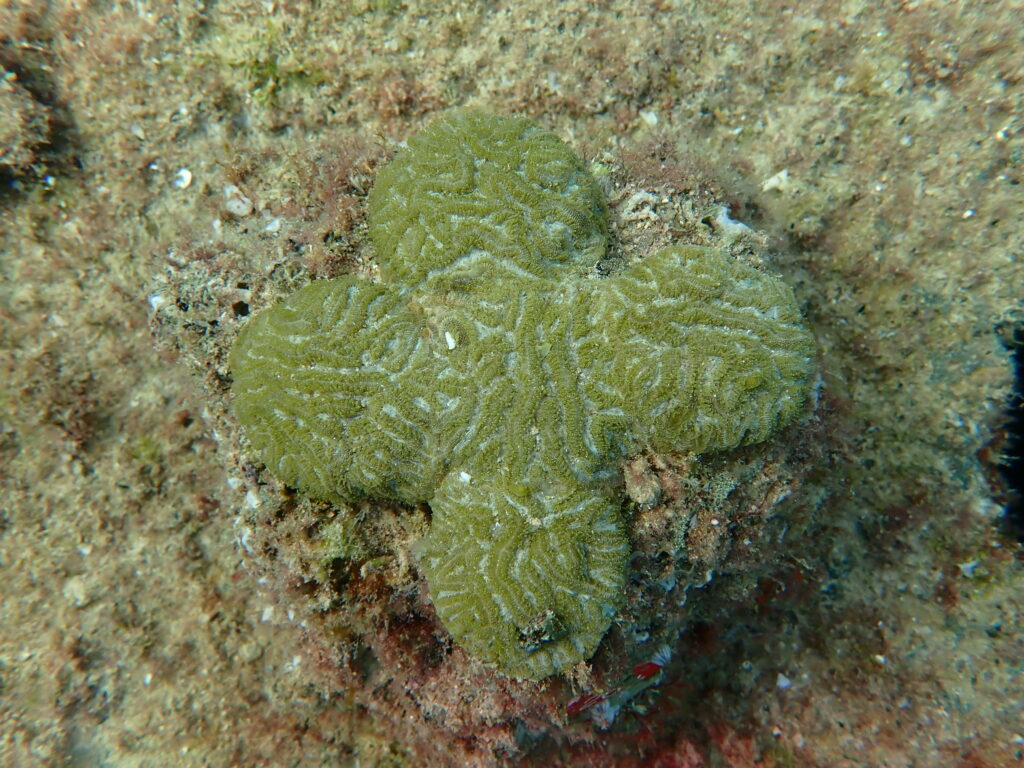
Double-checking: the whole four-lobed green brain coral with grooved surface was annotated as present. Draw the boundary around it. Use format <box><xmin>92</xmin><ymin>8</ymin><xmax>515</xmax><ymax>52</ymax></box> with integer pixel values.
<box><xmin>230</xmin><ymin>111</ymin><xmax>813</xmax><ymax>679</ymax></box>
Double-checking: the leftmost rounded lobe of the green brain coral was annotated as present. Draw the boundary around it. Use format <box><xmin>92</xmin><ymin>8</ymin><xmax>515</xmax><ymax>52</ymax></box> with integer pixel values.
<box><xmin>230</xmin><ymin>278</ymin><xmax>446</xmax><ymax>503</ymax></box>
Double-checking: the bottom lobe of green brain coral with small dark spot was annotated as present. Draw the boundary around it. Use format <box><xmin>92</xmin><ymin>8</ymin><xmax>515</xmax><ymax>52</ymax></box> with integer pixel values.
<box><xmin>422</xmin><ymin>474</ymin><xmax>629</xmax><ymax>679</ymax></box>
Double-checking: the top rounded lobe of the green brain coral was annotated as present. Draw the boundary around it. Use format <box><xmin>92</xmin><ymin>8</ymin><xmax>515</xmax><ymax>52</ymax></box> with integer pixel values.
<box><xmin>369</xmin><ymin>110</ymin><xmax>607</xmax><ymax>290</ymax></box>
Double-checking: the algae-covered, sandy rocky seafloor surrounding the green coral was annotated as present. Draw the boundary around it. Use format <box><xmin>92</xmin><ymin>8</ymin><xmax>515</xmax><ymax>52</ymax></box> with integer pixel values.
<box><xmin>0</xmin><ymin>0</ymin><xmax>1024</xmax><ymax>768</ymax></box>
